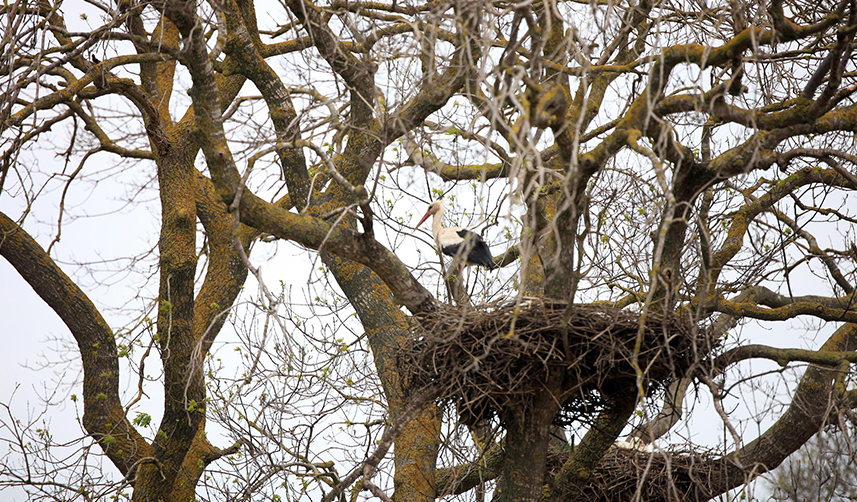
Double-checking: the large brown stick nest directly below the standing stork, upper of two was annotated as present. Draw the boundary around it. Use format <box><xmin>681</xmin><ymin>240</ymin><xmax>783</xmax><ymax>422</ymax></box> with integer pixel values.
<box><xmin>402</xmin><ymin>298</ymin><xmax>702</xmax><ymax>421</ymax></box>
